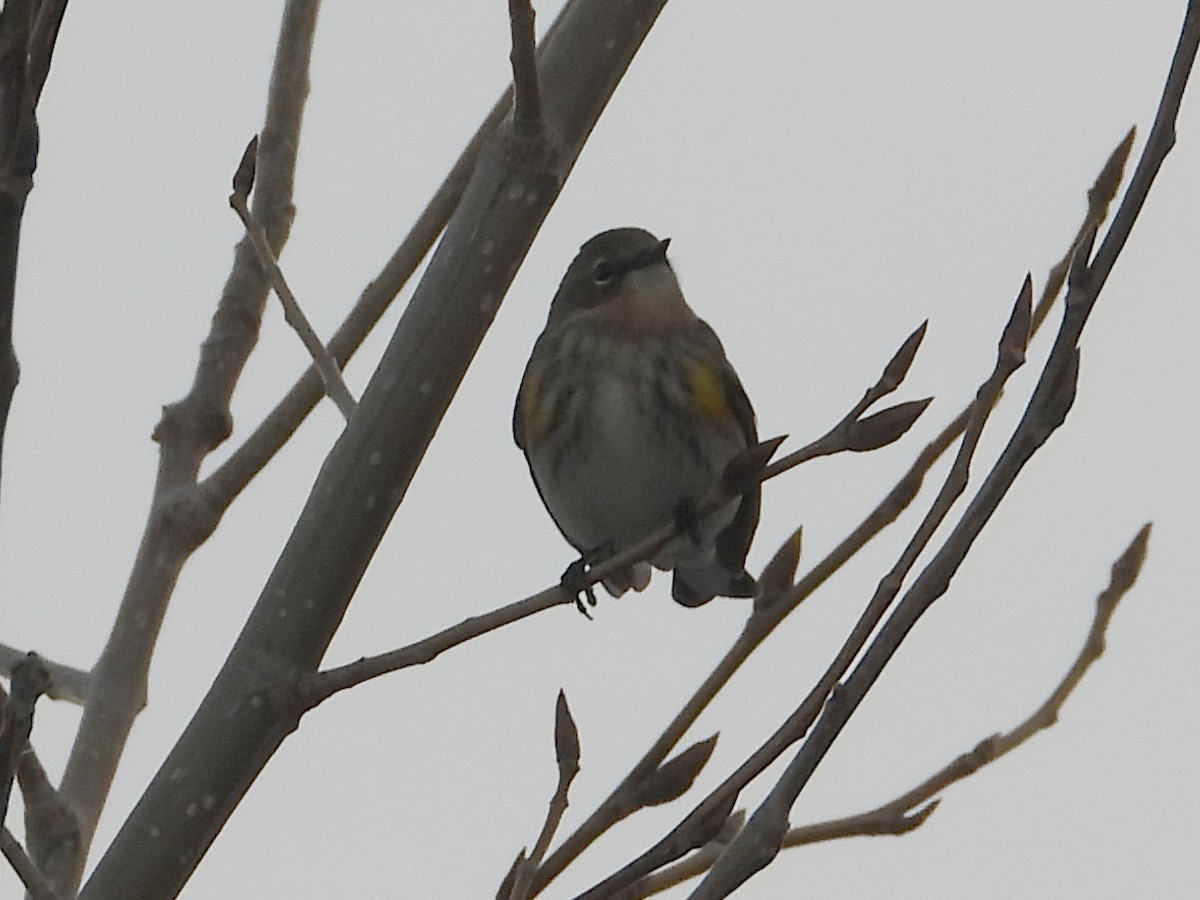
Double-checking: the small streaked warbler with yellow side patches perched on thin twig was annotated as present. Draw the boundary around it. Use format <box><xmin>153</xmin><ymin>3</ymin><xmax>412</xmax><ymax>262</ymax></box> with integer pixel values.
<box><xmin>512</xmin><ymin>228</ymin><xmax>760</xmax><ymax>606</ymax></box>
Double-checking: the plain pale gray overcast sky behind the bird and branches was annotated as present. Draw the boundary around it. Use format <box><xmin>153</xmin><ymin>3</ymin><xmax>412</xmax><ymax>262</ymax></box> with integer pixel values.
<box><xmin>0</xmin><ymin>0</ymin><xmax>1200</xmax><ymax>898</ymax></box>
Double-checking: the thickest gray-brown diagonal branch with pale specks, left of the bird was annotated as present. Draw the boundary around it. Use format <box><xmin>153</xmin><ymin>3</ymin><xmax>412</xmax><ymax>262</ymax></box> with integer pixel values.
<box><xmin>80</xmin><ymin>0</ymin><xmax>661</xmax><ymax>899</ymax></box>
